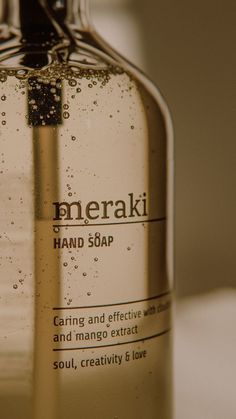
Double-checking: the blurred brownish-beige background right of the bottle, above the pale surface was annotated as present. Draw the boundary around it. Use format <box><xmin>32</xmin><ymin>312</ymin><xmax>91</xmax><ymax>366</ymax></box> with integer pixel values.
<box><xmin>91</xmin><ymin>0</ymin><xmax>236</xmax><ymax>296</ymax></box>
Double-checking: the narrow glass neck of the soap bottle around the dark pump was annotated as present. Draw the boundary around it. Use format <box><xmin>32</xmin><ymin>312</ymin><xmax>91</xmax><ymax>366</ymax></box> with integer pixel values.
<box><xmin>0</xmin><ymin>0</ymin><xmax>90</xmax><ymax>35</ymax></box>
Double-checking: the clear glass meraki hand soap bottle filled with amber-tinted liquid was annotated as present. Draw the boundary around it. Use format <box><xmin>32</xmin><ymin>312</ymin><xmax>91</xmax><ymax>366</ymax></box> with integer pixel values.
<box><xmin>0</xmin><ymin>0</ymin><xmax>173</xmax><ymax>419</ymax></box>
